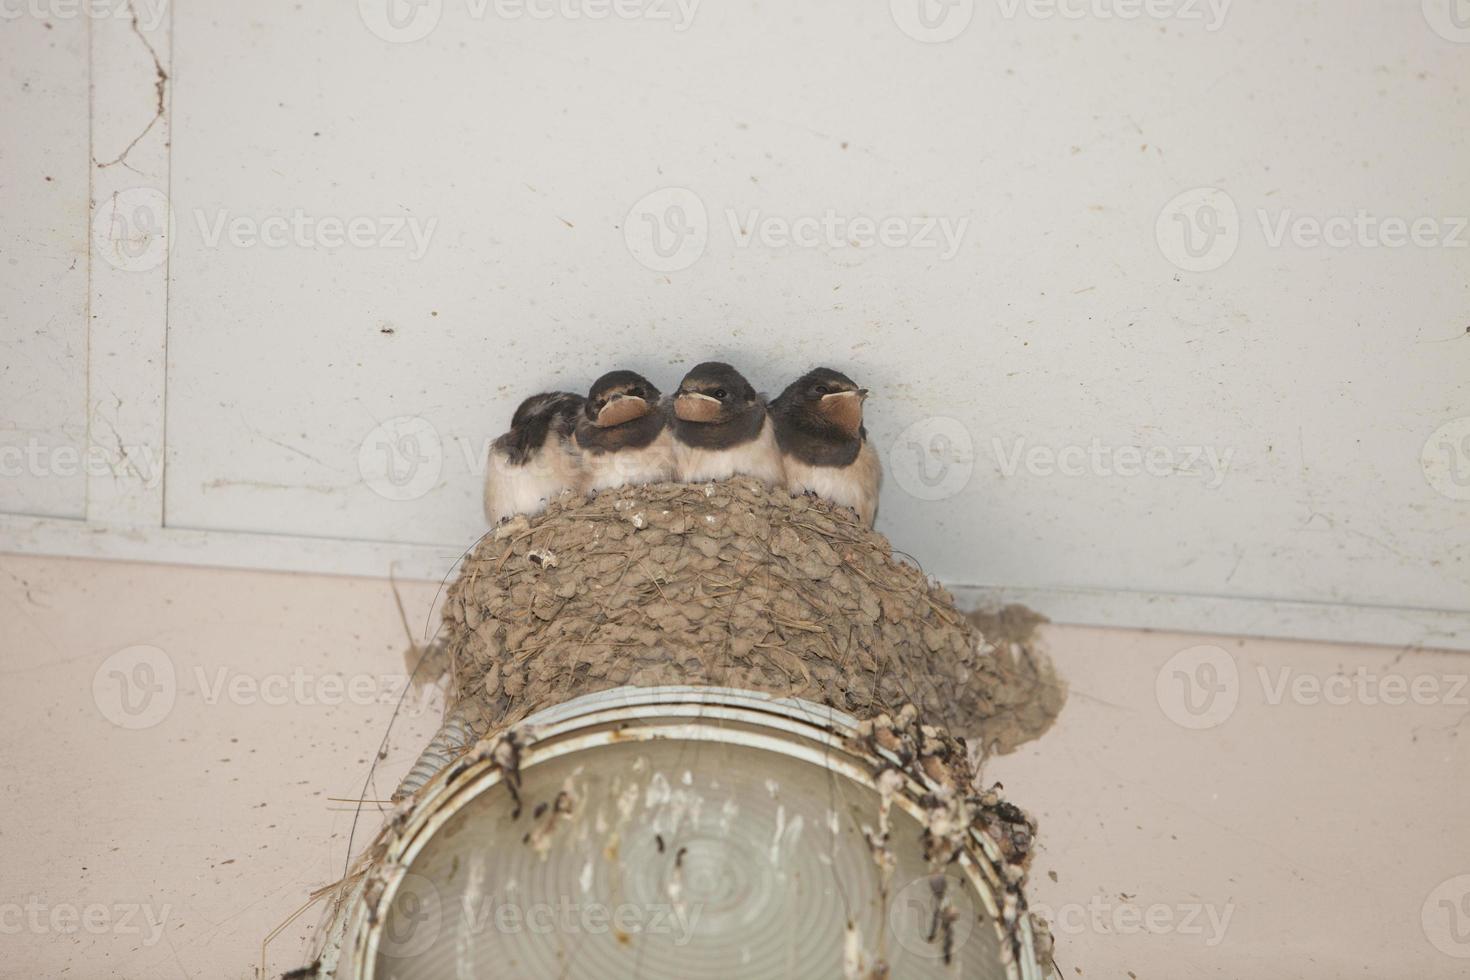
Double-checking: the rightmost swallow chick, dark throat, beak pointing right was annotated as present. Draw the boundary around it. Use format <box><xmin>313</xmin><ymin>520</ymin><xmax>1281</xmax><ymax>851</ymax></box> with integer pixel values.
<box><xmin>770</xmin><ymin>367</ymin><xmax>883</xmax><ymax>527</ymax></box>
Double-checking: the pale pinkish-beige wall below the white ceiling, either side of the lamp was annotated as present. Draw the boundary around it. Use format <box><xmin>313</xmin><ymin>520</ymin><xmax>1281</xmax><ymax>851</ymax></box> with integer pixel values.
<box><xmin>0</xmin><ymin>555</ymin><xmax>1470</xmax><ymax>980</ymax></box>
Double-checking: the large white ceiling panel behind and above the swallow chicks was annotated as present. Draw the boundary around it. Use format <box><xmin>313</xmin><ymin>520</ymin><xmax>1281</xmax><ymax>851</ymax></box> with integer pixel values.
<box><xmin>0</xmin><ymin>0</ymin><xmax>1470</xmax><ymax>646</ymax></box>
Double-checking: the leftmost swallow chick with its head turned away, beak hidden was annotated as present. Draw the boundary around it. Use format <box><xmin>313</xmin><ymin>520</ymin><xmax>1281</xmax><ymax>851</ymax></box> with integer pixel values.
<box><xmin>485</xmin><ymin>391</ymin><xmax>585</xmax><ymax>527</ymax></box>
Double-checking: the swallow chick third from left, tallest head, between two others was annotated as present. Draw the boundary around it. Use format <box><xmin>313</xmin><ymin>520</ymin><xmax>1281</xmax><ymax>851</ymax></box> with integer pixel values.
<box><xmin>672</xmin><ymin>361</ymin><xmax>785</xmax><ymax>486</ymax></box>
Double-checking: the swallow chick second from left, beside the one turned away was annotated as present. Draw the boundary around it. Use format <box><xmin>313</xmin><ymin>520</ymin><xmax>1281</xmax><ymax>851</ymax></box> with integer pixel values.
<box><xmin>575</xmin><ymin>370</ymin><xmax>673</xmax><ymax>494</ymax></box>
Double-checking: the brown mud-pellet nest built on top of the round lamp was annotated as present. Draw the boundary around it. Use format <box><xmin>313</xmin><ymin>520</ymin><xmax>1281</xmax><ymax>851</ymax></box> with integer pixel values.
<box><xmin>429</xmin><ymin>478</ymin><xmax>1064</xmax><ymax>752</ymax></box>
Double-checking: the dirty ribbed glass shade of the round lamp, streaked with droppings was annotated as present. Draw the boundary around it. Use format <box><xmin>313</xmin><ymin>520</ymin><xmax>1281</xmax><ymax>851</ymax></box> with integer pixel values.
<box><xmin>361</xmin><ymin>702</ymin><xmax>1008</xmax><ymax>980</ymax></box>
